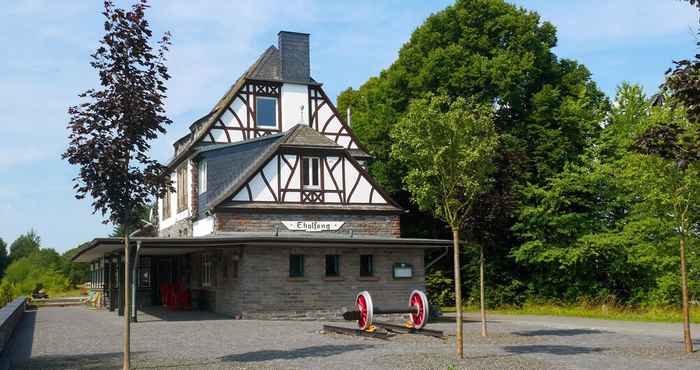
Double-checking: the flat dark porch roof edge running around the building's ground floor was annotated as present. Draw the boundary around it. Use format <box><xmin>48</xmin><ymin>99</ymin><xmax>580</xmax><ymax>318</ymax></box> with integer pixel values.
<box><xmin>73</xmin><ymin>232</ymin><xmax>452</xmax><ymax>262</ymax></box>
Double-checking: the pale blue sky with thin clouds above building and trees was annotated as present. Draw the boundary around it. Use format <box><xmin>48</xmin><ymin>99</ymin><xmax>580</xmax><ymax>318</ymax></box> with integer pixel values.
<box><xmin>0</xmin><ymin>0</ymin><xmax>698</xmax><ymax>251</ymax></box>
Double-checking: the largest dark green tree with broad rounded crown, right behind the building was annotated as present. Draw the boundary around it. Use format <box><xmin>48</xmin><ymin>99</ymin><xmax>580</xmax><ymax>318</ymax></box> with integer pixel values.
<box><xmin>338</xmin><ymin>0</ymin><xmax>608</xmax><ymax>303</ymax></box>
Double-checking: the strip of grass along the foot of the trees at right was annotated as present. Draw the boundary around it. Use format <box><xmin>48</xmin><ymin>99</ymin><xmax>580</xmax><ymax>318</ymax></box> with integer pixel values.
<box><xmin>441</xmin><ymin>303</ymin><xmax>700</xmax><ymax>324</ymax></box>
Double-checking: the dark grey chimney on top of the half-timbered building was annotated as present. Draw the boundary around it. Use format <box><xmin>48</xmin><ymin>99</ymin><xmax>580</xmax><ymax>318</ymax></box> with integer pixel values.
<box><xmin>277</xmin><ymin>31</ymin><xmax>311</xmax><ymax>82</ymax></box>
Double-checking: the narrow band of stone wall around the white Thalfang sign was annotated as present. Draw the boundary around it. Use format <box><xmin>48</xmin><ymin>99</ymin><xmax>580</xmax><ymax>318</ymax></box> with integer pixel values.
<box><xmin>215</xmin><ymin>211</ymin><xmax>401</xmax><ymax>238</ymax></box>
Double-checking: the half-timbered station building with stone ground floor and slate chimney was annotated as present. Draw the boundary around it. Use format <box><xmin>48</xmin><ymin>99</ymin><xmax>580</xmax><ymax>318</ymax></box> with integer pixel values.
<box><xmin>75</xmin><ymin>32</ymin><xmax>449</xmax><ymax>317</ymax></box>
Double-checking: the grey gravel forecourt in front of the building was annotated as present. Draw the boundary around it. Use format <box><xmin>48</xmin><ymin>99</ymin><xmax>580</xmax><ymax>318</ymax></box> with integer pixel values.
<box><xmin>4</xmin><ymin>307</ymin><xmax>700</xmax><ymax>370</ymax></box>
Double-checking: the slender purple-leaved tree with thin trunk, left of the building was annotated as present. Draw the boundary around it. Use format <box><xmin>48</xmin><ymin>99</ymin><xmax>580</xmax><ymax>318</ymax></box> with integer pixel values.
<box><xmin>63</xmin><ymin>0</ymin><xmax>171</xmax><ymax>369</ymax></box>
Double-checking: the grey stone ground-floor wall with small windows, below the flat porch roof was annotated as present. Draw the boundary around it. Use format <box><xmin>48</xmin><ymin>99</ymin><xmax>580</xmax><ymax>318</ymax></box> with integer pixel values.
<box><xmin>192</xmin><ymin>247</ymin><xmax>425</xmax><ymax>319</ymax></box>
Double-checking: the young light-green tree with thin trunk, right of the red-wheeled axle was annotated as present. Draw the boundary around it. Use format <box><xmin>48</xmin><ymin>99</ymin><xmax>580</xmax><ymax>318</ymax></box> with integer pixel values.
<box><xmin>391</xmin><ymin>96</ymin><xmax>499</xmax><ymax>358</ymax></box>
